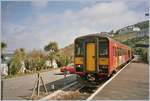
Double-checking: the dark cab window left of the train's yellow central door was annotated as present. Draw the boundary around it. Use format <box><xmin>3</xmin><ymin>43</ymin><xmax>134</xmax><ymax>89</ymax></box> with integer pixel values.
<box><xmin>75</xmin><ymin>42</ymin><xmax>83</xmax><ymax>56</ymax></box>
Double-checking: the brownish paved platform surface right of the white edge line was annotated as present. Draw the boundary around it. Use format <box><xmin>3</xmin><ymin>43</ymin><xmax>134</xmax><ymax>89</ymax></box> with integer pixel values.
<box><xmin>92</xmin><ymin>62</ymin><xmax>149</xmax><ymax>100</ymax></box>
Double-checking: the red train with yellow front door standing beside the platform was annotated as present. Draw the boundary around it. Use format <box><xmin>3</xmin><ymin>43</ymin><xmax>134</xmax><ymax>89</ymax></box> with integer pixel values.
<box><xmin>74</xmin><ymin>33</ymin><xmax>132</xmax><ymax>81</ymax></box>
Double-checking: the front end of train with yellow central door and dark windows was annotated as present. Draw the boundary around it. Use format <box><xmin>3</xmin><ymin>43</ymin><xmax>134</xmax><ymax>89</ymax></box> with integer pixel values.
<box><xmin>74</xmin><ymin>36</ymin><xmax>109</xmax><ymax>81</ymax></box>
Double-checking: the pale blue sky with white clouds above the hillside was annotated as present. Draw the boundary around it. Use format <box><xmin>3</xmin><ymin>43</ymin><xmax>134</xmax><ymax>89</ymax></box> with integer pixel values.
<box><xmin>1</xmin><ymin>0</ymin><xmax>149</xmax><ymax>52</ymax></box>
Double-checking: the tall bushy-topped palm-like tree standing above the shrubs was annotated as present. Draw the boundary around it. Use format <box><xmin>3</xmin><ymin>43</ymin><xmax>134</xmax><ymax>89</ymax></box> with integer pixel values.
<box><xmin>44</xmin><ymin>42</ymin><xmax>58</xmax><ymax>67</ymax></box>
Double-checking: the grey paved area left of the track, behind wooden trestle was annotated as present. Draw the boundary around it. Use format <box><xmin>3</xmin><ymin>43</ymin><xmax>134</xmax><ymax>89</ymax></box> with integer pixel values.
<box><xmin>3</xmin><ymin>69</ymin><xmax>76</xmax><ymax>100</ymax></box>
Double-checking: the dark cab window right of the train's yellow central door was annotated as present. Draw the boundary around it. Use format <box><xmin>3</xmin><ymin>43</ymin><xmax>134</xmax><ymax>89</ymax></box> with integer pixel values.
<box><xmin>99</xmin><ymin>40</ymin><xmax>108</xmax><ymax>56</ymax></box>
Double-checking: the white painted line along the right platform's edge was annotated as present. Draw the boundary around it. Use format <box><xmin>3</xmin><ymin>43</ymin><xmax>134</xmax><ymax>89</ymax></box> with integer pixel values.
<box><xmin>86</xmin><ymin>61</ymin><xmax>131</xmax><ymax>101</ymax></box>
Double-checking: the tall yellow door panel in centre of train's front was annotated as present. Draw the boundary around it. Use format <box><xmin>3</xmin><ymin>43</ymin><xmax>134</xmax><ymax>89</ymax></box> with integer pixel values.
<box><xmin>86</xmin><ymin>43</ymin><xmax>95</xmax><ymax>72</ymax></box>
